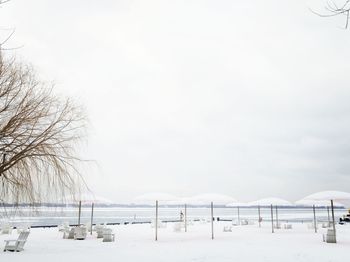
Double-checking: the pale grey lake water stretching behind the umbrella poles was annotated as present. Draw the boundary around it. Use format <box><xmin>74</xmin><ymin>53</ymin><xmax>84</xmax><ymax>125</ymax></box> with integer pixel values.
<box><xmin>0</xmin><ymin>207</ymin><xmax>347</xmax><ymax>226</ymax></box>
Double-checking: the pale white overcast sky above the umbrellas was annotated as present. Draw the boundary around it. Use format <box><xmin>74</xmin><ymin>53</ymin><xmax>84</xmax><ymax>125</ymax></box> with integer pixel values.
<box><xmin>0</xmin><ymin>0</ymin><xmax>350</xmax><ymax>202</ymax></box>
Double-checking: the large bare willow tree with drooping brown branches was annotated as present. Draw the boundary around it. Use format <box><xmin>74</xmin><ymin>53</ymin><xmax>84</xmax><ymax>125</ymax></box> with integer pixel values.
<box><xmin>0</xmin><ymin>56</ymin><xmax>86</xmax><ymax>203</ymax></box>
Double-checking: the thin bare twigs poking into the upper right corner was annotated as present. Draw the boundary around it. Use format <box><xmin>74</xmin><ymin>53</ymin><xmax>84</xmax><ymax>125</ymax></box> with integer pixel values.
<box><xmin>311</xmin><ymin>0</ymin><xmax>350</xmax><ymax>29</ymax></box>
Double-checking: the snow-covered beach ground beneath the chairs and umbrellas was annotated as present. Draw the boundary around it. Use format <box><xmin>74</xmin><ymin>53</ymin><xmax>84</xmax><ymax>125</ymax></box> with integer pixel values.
<box><xmin>0</xmin><ymin>222</ymin><xmax>350</xmax><ymax>262</ymax></box>
